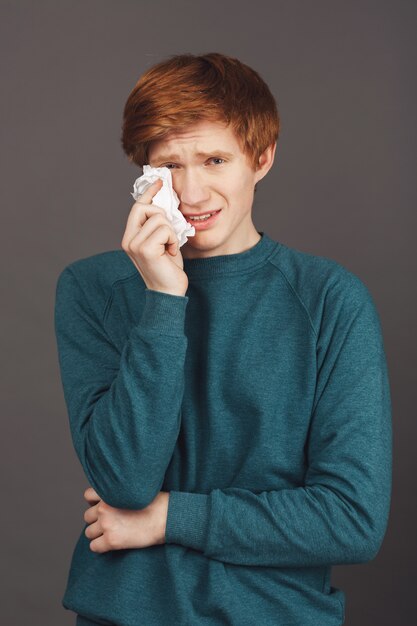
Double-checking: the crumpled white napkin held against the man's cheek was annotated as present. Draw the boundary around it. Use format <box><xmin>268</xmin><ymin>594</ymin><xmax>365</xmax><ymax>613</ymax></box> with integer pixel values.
<box><xmin>131</xmin><ymin>165</ymin><xmax>195</xmax><ymax>248</ymax></box>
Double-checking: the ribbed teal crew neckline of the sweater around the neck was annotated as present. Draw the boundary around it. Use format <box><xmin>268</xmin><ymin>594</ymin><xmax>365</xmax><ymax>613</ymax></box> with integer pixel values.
<box><xmin>183</xmin><ymin>231</ymin><xmax>280</xmax><ymax>279</ymax></box>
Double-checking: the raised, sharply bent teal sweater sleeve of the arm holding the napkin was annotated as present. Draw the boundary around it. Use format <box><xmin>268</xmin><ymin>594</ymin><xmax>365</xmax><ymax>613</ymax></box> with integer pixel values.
<box><xmin>55</xmin><ymin>267</ymin><xmax>188</xmax><ymax>509</ymax></box>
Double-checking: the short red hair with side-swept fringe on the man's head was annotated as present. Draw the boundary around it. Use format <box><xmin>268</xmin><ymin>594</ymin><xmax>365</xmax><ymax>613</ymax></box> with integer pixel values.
<box><xmin>121</xmin><ymin>52</ymin><xmax>280</xmax><ymax>169</ymax></box>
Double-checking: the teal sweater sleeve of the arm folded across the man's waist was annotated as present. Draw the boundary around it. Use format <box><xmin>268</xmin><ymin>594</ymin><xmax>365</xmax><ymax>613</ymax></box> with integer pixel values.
<box><xmin>166</xmin><ymin>282</ymin><xmax>392</xmax><ymax>567</ymax></box>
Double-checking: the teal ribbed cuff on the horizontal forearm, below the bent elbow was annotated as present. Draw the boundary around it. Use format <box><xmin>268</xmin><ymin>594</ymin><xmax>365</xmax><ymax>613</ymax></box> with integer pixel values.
<box><xmin>165</xmin><ymin>491</ymin><xmax>210</xmax><ymax>552</ymax></box>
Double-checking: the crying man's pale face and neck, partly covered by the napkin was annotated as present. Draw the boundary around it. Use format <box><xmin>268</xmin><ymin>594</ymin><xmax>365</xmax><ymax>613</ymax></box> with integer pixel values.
<box><xmin>148</xmin><ymin>121</ymin><xmax>275</xmax><ymax>258</ymax></box>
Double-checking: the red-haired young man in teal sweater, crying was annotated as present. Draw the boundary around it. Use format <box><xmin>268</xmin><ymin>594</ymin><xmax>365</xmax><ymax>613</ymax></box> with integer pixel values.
<box><xmin>55</xmin><ymin>53</ymin><xmax>391</xmax><ymax>626</ymax></box>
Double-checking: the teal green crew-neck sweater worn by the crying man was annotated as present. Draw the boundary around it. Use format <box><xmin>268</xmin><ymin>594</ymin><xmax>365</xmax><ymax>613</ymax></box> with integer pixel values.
<box><xmin>55</xmin><ymin>232</ymin><xmax>392</xmax><ymax>626</ymax></box>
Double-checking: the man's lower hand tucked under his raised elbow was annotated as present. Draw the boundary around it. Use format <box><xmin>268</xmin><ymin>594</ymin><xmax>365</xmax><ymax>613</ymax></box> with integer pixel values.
<box><xmin>84</xmin><ymin>487</ymin><xmax>169</xmax><ymax>553</ymax></box>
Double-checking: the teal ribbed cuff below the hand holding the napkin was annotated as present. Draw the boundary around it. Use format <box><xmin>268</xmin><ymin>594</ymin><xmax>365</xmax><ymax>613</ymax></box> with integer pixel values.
<box><xmin>139</xmin><ymin>289</ymin><xmax>189</xmax><ymax>335</ymax></box>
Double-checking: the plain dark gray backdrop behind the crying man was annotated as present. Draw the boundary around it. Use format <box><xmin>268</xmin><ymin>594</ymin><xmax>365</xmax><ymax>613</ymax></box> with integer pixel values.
<box><xmin>0</xmin><ymin>0</ymin><xmax>417</xmax><ymax>626</ymax></box>
